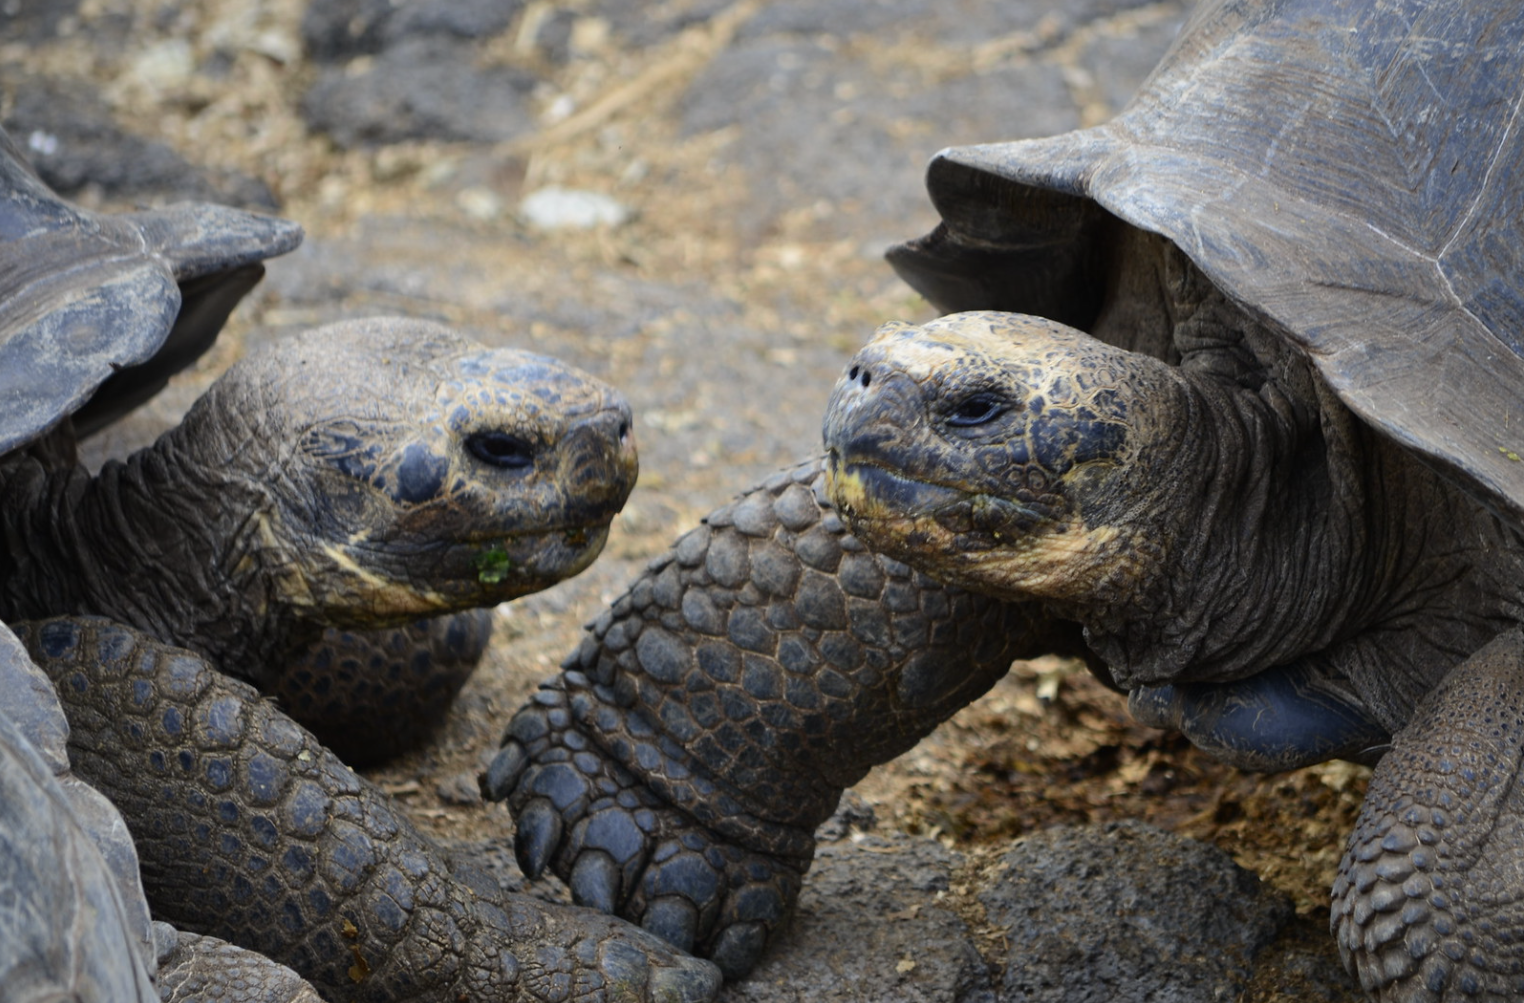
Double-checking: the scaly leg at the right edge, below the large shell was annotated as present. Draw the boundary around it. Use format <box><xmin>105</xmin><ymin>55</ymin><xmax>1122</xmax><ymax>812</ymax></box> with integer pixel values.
<box><xmin>1332</xmin><ymin>631</ymin><xmax>1524</xmax><ymax>1003</ymax></box>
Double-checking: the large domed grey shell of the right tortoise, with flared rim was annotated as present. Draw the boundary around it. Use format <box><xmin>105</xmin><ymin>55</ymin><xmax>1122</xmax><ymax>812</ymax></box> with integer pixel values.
<box><xmin>890</xmin><ymin>0</ymin><xmax>1524</xmax><ymax>521</ymax></box>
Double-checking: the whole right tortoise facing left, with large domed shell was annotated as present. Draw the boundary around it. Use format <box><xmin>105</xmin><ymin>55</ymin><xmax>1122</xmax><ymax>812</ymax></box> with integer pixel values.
<box><xmin>485</xmin><ymin>0</ymin><xmax>1524</xmax><ymax>1000</ymax></box>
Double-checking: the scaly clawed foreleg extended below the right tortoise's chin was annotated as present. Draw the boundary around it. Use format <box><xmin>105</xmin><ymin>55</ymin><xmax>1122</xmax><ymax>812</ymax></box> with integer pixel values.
<box><xmin>483</xmin><ymin>462</ymin><xmax>1077</xmax><ymax>977</ymax></box>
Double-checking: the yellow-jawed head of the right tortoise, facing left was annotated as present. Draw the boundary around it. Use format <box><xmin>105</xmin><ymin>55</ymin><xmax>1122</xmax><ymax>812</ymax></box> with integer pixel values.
<box><xmin>824</xmin><ymin>312</ymin><xmax>1158</xmax><ymax>601</ymax></box>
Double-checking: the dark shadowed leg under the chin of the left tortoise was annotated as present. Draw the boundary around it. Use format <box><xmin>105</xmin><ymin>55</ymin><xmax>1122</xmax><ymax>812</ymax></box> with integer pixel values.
<box><xmin>264</xmin><ymin>610</ymin><xmax>492</xmax><ymax>767</ymax></box>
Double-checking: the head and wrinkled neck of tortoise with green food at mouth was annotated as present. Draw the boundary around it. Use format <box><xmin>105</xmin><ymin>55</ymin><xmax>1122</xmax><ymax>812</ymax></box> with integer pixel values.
<box><xmin>0</xmin><ymin>319</ymin><xmax>637</xmax><ymax>746</ymax></box>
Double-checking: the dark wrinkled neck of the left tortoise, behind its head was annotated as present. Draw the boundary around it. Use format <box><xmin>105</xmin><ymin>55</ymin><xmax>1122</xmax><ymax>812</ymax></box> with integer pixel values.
<box><xmin>0</xmin><ymin>425</ymin><xmax>320</xmax><ymax>675</ymax></box>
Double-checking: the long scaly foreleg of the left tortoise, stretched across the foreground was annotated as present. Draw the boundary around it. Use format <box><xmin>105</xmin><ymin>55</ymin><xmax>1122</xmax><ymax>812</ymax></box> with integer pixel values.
<box><xmin>18</xmin><ymin>617</ymin><xmax>718</xmax><ymax>1003</ymax></box>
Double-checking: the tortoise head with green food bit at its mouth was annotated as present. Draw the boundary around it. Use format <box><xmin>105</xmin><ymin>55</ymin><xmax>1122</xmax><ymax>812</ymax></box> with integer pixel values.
<box><xmin>181</xmin><ymin>320</ymin><xmax>637</xmax><ymax>626</ymax></box>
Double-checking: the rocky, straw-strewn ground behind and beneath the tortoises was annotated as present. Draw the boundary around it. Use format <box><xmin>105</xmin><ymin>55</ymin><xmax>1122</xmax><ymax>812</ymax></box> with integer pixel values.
<box><xmin>0</xmin><ymin>0</ymin><xmax>1364</xmax><ymax>1001</ymax></box>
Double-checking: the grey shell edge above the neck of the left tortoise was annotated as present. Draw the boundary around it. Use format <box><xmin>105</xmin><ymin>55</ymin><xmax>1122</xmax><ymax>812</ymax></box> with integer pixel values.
<box><xmin>0</xmin><ymin>125</ymin><xmax>302</xmax><ymax>456</ymax></box>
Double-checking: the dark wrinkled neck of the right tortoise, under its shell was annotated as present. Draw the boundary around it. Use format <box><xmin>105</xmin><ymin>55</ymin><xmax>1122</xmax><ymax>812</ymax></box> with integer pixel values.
<box><xmin>1058</xmin><ymin>332</ymin><xmax>1434</xmax><ymax>687</ymax></box>
